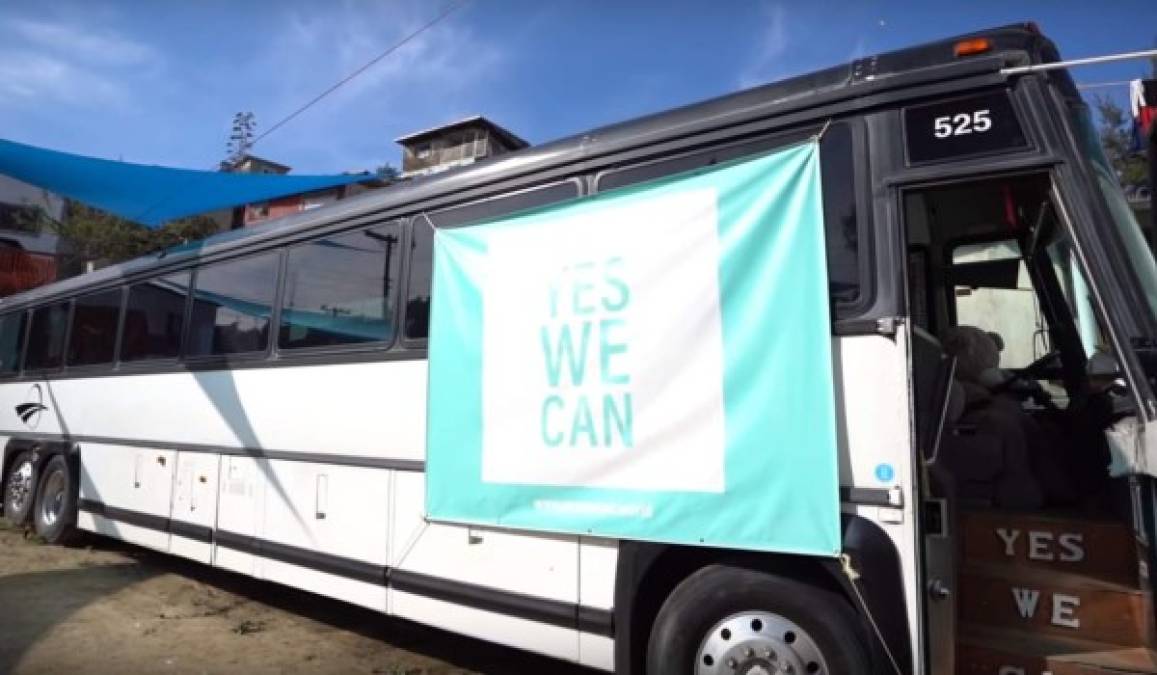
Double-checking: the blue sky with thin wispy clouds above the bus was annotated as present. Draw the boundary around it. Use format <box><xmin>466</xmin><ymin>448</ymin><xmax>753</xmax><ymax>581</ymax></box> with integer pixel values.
<box><xmin>0</xmin><ymin>0</ymin><xmax>1157</xmax><ymax>173</ymax></box>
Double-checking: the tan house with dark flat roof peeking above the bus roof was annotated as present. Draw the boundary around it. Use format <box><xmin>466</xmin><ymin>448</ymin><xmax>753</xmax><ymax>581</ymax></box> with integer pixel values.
<box><xmin>396</xmin><ymin>115</ymin><xmax>530</xmax><ymax>178</ymax></box>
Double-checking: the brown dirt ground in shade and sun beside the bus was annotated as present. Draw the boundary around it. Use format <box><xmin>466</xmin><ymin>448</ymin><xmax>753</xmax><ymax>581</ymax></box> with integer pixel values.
<box><xmin>0</xmin><ymin>521</ymin><xmax>592</xmax><ymax>675</ymax></box>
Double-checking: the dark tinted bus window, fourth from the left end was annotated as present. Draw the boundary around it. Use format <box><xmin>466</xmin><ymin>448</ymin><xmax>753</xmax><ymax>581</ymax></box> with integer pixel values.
<box><xmin>120</xmin><ymin>272</ymin><xmax>190</xmax><ymax>361</ymax></box>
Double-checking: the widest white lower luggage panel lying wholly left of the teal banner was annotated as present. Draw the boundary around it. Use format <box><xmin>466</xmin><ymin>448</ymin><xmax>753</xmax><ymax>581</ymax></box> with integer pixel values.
<box><xmin>258</xmin><ymin>460</ymin><xmax>390</xmax><ymax>612</ymax></box>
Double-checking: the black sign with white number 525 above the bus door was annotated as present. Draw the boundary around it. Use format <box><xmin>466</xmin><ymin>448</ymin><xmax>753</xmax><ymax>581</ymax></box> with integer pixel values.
<box><xmin>904</xmin><ymin>91</ymin><xmax>1029</xmax><ymax>163</ymax></box>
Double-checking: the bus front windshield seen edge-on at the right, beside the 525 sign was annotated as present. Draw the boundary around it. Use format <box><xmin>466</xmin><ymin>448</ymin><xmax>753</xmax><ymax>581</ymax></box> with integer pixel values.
<box><xmin>1069</xmin><ymin>105</ymin><xmax>1157</xmax><ymax>326</ymax></box>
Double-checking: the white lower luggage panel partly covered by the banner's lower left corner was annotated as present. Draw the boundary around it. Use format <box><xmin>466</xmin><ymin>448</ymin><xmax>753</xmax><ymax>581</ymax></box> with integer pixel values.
<box><xmin>390</xmin><ymin>471</ymin><xmax>579</xmax><ymax>661</ymax></box>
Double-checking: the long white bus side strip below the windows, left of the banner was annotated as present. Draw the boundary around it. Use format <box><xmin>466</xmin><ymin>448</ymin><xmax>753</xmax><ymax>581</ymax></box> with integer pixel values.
<box><xmin>38</xmin><ymin>360</ymin><xmax>426</xmax><ymax>461</ymax></box>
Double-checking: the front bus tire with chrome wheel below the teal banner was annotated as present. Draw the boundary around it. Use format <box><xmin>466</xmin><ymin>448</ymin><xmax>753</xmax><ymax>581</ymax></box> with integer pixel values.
<box><xmin>647</xmin><ymin>565</ymin><xmax>871</xmax><ymax>675</ymax></box>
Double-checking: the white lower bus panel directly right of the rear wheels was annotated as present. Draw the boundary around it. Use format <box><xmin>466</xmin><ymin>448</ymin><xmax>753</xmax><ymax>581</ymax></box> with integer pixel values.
<box><xmin>79</xmin><ymin>443</ymin><xmax>177</xmax><ymax>551</ymax></box>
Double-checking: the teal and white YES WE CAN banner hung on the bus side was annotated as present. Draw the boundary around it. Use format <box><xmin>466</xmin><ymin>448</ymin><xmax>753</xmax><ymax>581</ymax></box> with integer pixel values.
<box><xmin>425</xmin><ymin>142</ymin><xmax>840</xmax><ymax>556</ymax></box>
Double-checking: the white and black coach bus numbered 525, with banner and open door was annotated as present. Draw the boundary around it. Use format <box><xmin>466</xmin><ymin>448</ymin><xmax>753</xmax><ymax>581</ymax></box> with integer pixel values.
<box><xmin>0</xmin><ymin>23</ymin><xmax>1157</xmax><ymax>675</ymax></box>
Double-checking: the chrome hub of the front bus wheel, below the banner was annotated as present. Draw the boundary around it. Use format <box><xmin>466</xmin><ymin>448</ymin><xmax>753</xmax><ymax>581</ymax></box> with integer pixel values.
<box><xmin>695</xmin><ymin>611</ymin><xmax>830</xmax><ymax>675</ymax></box>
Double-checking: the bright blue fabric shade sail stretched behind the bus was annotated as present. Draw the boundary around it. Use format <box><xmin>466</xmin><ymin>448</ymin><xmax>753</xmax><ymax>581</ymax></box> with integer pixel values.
<box><xmin>0</xmin><ymin>139</ymin><xmax>374</xmax><ymax>227</ymax></box>
